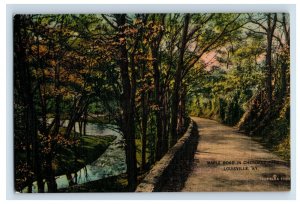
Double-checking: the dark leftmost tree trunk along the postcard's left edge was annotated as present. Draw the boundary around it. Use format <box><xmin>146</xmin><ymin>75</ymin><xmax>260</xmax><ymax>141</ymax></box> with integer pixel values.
<box><xmin>14</xmin><ymin>15</ymin><xmax>43</xmax><ymax>192</ymax></box>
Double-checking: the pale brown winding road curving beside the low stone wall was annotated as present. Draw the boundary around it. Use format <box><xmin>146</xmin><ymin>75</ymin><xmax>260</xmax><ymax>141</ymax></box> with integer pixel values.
<box><xmin>182</xmin><ymin>117</ymin><xmax>290</xmax><ymax>192</ymax></box>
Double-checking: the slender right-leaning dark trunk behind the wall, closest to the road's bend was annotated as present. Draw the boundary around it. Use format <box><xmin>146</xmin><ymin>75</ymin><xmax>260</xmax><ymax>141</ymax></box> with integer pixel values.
<box><xmin>171</xmin><ymin>14</ymin><xmax>190</xmax><ymax>145</ymax></box>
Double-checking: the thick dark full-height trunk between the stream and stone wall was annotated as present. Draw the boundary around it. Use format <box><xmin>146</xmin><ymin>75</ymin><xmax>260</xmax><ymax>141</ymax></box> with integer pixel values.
<box><xmin>115</xmin><ymin>14</ymin><xmax>137</xmax><ymax>191</ymax></box>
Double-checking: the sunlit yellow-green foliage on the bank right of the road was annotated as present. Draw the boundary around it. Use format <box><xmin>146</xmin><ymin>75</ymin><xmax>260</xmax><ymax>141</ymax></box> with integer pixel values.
<box><xmin>188</xmin><ymin>14</ymin><xmax>290</xmax><ymax>163</ymax></box>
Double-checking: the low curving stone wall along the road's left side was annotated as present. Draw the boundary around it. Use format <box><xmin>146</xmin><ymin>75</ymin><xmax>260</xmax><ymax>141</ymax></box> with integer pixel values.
<box><xmin>136</xmin><ymin>120</ymin><xmax>198</xmax><ymax>192</ymax></box>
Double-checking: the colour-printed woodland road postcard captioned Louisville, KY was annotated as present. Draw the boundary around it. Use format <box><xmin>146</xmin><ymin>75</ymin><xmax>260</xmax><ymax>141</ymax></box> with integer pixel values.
<box><xmin>13</xmin><ymin>13</ymin><xmax>291</xmax><ymax>193</ymax></box>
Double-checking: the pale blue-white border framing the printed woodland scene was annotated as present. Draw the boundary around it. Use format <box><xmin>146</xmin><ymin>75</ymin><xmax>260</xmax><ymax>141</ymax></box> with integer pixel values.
<box><xmin>6</xmin><ymin>4</ymin><xmax>296</xmax><ymax>202</ymax></box>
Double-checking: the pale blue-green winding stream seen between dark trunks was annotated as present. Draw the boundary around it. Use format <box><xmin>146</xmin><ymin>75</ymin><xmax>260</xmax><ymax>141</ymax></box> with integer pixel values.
<box><xmin>23</xmin><ymin>121</ymin><xmax>126</xmax><ymax>192</ymax></box>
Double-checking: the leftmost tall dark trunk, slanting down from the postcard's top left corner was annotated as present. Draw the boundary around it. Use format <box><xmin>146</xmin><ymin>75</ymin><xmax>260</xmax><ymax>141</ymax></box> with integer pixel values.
<box><xmin>14</xmin><ymin>15</ymin><xmax>44</xmax><ymax>192</ymax></box>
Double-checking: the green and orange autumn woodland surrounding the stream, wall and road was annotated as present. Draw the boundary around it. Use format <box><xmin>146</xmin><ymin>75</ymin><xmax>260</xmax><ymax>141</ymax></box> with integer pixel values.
<box><xmin>14</xmin><ymin>13</ymin><xmax>290</xmax><ymax>191</ymax></box>
